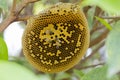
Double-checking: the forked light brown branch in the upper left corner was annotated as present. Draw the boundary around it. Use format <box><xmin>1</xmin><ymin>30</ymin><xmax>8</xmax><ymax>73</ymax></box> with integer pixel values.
<box><xmin>0</xmin><ymin>0</ymin><xmax>39</xmax><ymax>33</ymax></box>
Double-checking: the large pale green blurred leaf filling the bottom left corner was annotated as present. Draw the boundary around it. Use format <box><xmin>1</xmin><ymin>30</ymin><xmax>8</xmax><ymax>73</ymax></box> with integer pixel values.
<box><xmin>0</xmin><ymin>60</ymin><xmax>39</xmax><ymax>80</ymax></box>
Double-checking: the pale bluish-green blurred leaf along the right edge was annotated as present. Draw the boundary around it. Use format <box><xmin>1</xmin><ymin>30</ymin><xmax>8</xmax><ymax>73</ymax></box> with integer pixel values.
<box><xmin>106</xmin><ymin>22</ymin><xmax>120</xmax><ymax>76</ymax></box>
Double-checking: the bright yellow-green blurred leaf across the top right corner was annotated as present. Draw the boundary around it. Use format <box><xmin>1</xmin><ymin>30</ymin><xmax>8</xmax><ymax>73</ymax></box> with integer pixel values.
<box><xmin>82</xmin><ymin>0</ymin><xmax>120</xmax><ymax>14</ymax></box>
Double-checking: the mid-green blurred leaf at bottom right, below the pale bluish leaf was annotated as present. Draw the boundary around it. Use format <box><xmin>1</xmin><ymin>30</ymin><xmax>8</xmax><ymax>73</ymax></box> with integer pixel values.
<box><xmin>81</xmin><ymin>66</ymin><xmax>119</xmax><ymax>80</ymax></box>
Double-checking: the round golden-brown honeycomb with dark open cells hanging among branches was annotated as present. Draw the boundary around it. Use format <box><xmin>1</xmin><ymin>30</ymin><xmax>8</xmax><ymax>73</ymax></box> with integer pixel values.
<box><xmin>22</xmin><ymin>3</ymin><xmax>89</xmax><ymax>73</ymax></box>
